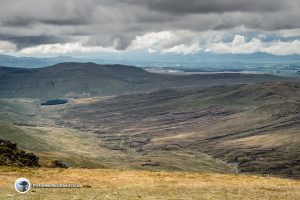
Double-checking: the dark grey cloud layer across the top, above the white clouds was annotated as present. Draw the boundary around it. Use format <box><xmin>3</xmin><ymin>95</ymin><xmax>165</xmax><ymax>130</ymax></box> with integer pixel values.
<box><xmin>0</xmin><ymin>0</ymin><xmax>300</xmax><ymax>50</ymax></box>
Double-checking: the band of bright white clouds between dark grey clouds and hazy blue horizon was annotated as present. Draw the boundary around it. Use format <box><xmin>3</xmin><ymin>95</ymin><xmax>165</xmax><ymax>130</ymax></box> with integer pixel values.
<box><xmin>0</xmin><ymin>27</ymin><xmax>300</xmax><ymax>55</ymax></box>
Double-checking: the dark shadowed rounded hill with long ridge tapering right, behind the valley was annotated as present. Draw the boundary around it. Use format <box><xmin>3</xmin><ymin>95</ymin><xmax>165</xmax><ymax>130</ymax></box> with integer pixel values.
<box><xmin>0</xmin><ymin>62</ymin><xmax>283</xmax><ymax>99</ymax></box>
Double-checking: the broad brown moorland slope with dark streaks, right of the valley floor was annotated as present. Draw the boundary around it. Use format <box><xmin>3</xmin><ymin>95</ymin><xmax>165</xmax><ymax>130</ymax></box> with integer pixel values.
<box><xmin>49</xmin><ymin>82</ymin><xmax>300</xmax><ymax>177</ymax></box>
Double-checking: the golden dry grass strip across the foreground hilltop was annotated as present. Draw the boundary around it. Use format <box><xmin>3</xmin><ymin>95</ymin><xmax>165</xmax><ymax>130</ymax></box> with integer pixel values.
<box><xmin>0</xmin><ymin>167</ymin><xmax>300</xmax><ymax>200</ymax></box>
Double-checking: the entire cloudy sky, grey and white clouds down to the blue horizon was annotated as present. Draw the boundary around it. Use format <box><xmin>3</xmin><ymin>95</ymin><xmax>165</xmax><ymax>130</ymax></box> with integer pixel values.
<box><xmin>0</xmin><ymin>0</ymin><xmax>300</xmax><ymax>56</ymax></box>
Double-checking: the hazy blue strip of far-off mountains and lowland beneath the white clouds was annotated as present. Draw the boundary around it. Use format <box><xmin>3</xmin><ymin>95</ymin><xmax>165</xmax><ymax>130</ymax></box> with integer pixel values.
<box><xmin>0</xmin><ymin>52</ymin><xmax>300</xmax><ymax>70</ymax></box>
